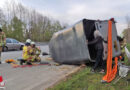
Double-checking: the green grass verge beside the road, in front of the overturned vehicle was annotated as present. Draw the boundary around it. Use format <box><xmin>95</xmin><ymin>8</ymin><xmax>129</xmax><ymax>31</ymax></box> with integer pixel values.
<box><xmin>48</xmin><ymin>44</ymin><xmax>130</xmax><ymax>90</ymax></box>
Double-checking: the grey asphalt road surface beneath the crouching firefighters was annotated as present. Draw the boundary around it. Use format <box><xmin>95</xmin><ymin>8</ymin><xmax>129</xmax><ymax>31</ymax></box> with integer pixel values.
<box><xmin>0</xmin><ymin>45</ymin><xmax>77</xmax><ymax>90</ymax></box>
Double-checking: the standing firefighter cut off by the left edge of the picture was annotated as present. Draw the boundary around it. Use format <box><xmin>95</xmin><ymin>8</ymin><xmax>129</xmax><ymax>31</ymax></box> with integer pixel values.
<box><xmin>0</xmin><ymin>28</ymin><xmax>6</xmax><ymax>64</ymax></box>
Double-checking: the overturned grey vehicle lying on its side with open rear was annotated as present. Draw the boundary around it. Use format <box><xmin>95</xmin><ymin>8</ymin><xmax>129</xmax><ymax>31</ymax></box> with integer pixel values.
<box><xmin>49</xmin><ymin>19</ymin><xmax>121</xmax><ymax>64</ymax></box>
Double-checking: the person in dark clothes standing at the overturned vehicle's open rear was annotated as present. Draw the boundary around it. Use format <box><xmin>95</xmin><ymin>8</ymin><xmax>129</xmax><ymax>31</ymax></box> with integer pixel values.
<box><xmin>87</xmin><ymin>30</ymin><xmax>105</xmax><ymax>73</ymax></box>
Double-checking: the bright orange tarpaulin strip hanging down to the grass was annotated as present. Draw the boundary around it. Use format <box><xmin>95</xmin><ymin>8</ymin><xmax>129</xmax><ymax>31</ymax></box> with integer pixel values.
<box><xmin>103</xmin><ymin>20</ymin><xmax>118</xmax><ymax>82</ymax></box>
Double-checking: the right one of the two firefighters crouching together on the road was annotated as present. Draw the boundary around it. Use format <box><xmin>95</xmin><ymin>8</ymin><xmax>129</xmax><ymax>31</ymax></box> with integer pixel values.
<box><xmin>31</xmin><ymin>42</ymin><xmax>41</xmax><ymax>62</ymax></box>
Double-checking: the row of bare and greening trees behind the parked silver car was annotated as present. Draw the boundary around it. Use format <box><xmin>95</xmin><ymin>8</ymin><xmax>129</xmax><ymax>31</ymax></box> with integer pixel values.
<box><xmin>0</xmin><ymin>1</ymin><xmax>62</xmax><ymax>41</ymax></box>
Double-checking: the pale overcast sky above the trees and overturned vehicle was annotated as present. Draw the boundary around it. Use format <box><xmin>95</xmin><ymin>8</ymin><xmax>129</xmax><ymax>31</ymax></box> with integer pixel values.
<box><xmin>0</xmin><ymin>0</ymin><xmax>130</xmax><ymax>34</ymax></box>
